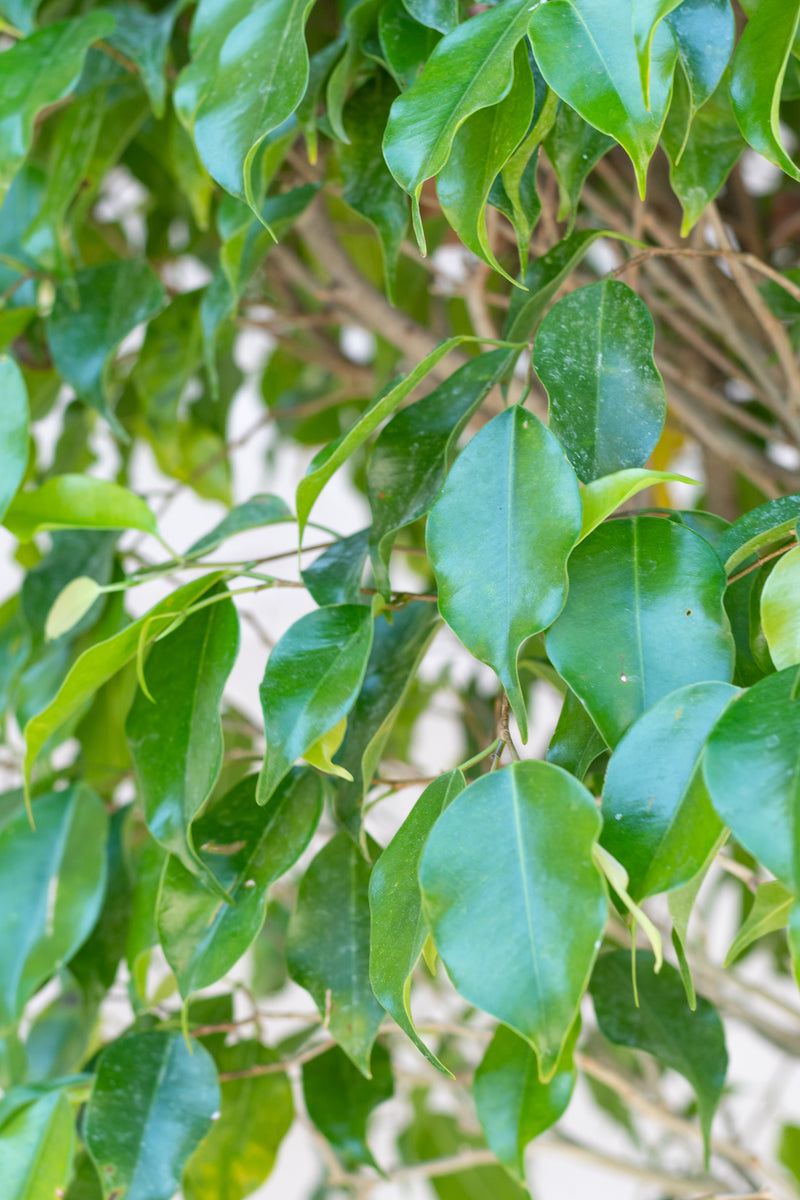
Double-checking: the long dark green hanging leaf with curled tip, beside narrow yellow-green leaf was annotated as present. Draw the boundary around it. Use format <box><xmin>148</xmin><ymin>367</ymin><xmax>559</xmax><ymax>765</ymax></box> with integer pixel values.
<box><xmin>126</xmin><ymin>583</ymin><xmax>239</xmax><ymax>882</ymax></box>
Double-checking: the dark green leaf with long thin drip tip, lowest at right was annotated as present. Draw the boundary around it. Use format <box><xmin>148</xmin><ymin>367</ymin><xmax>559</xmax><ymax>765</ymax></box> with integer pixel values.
<box><xmin>591</xmin><ymin>950</ymin><xmax>728</xmax><ymax>1165</ymax></box>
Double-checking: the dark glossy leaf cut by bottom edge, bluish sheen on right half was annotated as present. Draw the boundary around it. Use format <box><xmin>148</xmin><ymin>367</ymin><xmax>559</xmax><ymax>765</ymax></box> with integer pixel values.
<box><xmin>84</xmin><ymin>1031</ymin><xmax>219</xmax><ymax>1200</ymax></box>
